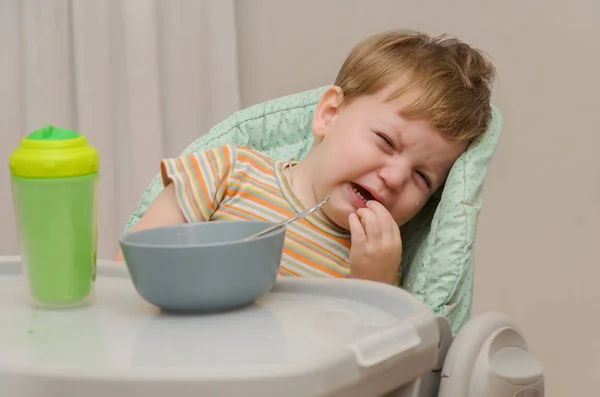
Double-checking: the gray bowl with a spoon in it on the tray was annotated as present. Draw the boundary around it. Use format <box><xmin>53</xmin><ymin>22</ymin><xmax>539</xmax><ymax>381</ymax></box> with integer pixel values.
<box><xmin>120</xmin><ymin>221</ymin><xmax>285</xmax><ymax>312</ymax></box>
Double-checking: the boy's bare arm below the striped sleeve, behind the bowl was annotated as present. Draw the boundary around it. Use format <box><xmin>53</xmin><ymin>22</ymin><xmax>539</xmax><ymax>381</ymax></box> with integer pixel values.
<box><xmin>114</xmin><ymin>183</ymin><xmax>186</xmax><ymax>262</ymax></box>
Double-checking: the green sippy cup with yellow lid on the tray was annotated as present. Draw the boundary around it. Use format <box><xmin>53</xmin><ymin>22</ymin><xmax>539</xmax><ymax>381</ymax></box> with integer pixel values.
<box><xmin>9</xmin><ymin>125</ymin><xmax>100</xmax><ymax>309</ymax></box>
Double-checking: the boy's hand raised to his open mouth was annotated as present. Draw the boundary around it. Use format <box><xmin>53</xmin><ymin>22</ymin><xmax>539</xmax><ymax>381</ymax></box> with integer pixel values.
<box><xmin>349</xmin><ymin>200</ymin><xmax>402</xmax><ymax>284</ymax></box>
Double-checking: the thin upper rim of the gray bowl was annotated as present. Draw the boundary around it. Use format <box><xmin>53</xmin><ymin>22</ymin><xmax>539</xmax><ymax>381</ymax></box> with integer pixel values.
<box><xmin>119</xmin><ymin>219</ymin><xmax>287</xmax><ymax>248</ymax></box>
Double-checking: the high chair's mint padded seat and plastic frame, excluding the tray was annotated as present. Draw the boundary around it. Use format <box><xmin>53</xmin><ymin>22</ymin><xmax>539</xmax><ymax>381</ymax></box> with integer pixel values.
<box><xmin>125</xmin><ymin>87</ymin><xmax>544</xmax><ymax>397</ymax></box>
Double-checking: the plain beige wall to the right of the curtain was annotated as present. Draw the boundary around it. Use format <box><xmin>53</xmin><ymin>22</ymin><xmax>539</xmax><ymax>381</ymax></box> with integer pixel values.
<box><xmin>237</xmin><ymin>0</ymin><xmax>600</xmax><ymax>397</ymax></box>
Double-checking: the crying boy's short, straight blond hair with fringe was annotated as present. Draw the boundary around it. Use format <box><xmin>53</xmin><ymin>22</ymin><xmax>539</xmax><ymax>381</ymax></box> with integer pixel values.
<box><xmin>335</xmin><ymin>31</ymin><xmax>495</xmax><ymax>140</ymax></box>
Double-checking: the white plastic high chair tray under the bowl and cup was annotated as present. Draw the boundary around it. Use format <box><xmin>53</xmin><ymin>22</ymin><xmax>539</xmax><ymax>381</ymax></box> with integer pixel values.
<box><xmin>0</xmin><ymin>257</ymin><xmax>438</xmax><ymax>397</ymax></box>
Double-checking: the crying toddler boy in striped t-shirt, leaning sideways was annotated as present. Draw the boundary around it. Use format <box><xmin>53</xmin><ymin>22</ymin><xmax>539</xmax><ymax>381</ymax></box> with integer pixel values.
<box><xmin>117</xmin><ymin>31</ymin><xmax>495</xmax><ymax>284</ymax></box>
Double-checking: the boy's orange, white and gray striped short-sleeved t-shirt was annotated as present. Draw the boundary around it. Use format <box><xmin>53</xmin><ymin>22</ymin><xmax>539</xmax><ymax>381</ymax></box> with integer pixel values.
<box><xmin>161</xmin><ymin>145</ymin><xmax>350</xmax><ymax>277</ymax></box>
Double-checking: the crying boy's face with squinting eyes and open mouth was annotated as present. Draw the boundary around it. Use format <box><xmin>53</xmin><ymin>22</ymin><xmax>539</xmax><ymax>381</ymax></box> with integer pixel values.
<box><xmin>306</xmin><ymin>87</ymin><xmax>467</xmax><ymax>229</ymax></box>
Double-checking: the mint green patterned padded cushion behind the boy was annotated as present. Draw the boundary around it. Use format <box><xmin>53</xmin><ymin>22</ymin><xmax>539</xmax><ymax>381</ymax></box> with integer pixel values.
<box><xmin>125</xmin><ymin>87</ymin><xmax>502</xmax><ymax>333</ymax></box>
